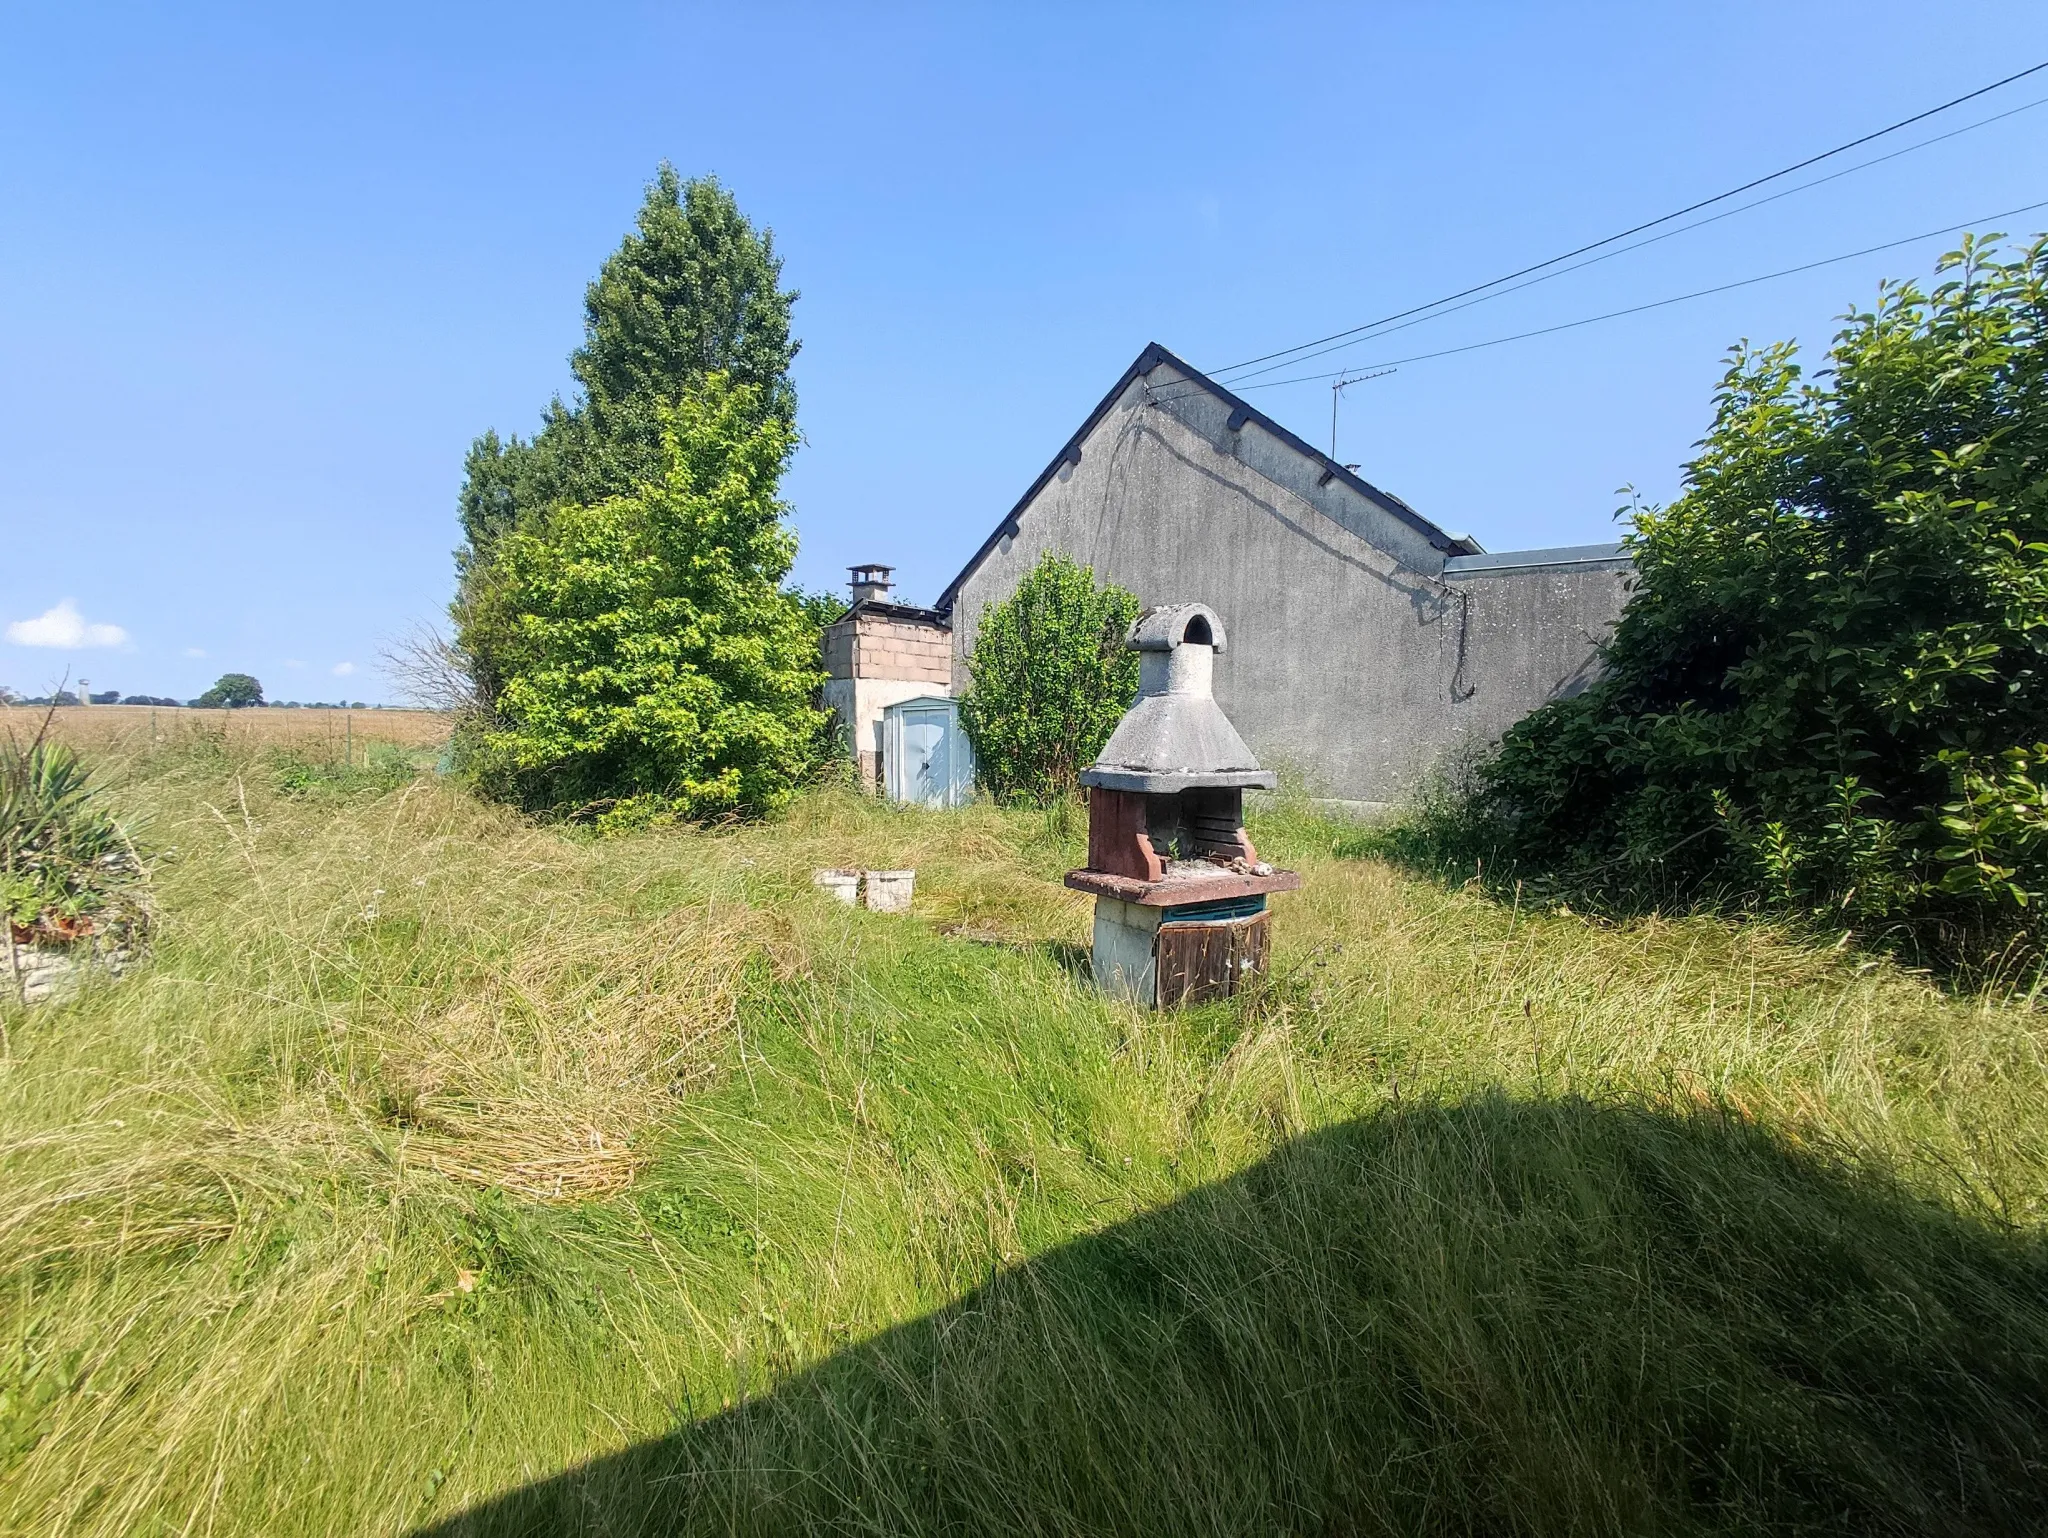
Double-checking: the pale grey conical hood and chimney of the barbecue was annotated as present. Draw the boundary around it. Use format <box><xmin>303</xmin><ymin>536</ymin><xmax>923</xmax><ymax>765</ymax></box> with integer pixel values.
<box><xmin>1081</xmin><ymin>604</ymin><xmax>1280</xmax><ymax>795</ymax></box>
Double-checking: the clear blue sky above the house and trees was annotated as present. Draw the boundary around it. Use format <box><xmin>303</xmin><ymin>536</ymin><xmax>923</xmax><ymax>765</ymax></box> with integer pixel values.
<box><xmin>0</xmin><ymin>0</ymin><xmax>2048</xmax><ymax>700</ymax></box>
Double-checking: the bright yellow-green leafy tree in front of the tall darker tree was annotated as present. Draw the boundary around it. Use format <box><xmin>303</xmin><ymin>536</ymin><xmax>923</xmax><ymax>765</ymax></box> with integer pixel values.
<box><xmin>465</xmin><ymin>373</ymin><xmax>821</xmax><ymax>827</ymax></box>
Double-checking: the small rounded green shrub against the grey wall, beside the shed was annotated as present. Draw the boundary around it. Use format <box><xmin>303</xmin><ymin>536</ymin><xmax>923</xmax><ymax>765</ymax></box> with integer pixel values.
<box><xmin>961</xmin><ymin>553</ymin><xmax>1139</xmax><ymax>803</ymax></box>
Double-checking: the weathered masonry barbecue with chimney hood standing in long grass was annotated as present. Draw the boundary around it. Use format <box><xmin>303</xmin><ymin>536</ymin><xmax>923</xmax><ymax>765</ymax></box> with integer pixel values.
<box><xmin>1067</xmin><ymin>604</ymin><xmax>1300</xmax><ymax>1008</ymax></box>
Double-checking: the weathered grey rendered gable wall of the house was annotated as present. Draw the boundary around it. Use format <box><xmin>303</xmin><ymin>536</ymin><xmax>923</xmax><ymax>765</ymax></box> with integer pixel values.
<box><xmin>948</xmin><ymin>348</ymin><xmax>1626</xmax><ymax>803</ymax></box>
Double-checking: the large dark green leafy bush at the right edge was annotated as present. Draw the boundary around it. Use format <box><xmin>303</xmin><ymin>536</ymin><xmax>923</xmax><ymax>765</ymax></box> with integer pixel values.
<box><xmin>1464</xmin><ymin>240</ymin><xmax>2048</xmax><ymax>965</ymax></box>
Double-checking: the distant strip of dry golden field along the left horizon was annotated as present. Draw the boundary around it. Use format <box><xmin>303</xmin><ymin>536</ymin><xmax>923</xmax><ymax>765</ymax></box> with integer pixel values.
<box><xmin>0</xmin><ymin>704</ymin><xmax>455</xmax><ymax>758</ymax></box>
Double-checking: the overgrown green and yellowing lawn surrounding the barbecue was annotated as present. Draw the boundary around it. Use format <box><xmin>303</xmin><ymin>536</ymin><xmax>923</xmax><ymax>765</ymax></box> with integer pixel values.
<box><xmin>0</xmin><ymin>741</ymin><xmax>2048</xmax><ymax>1538</ymax></box>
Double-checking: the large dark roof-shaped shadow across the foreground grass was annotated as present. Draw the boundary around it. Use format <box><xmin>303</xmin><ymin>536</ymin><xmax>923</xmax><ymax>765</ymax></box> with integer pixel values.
<box><xmin>415</xmin><ymin>1096</ymin><xmax>2048</xmax><ymax>1538</ymax></box>
